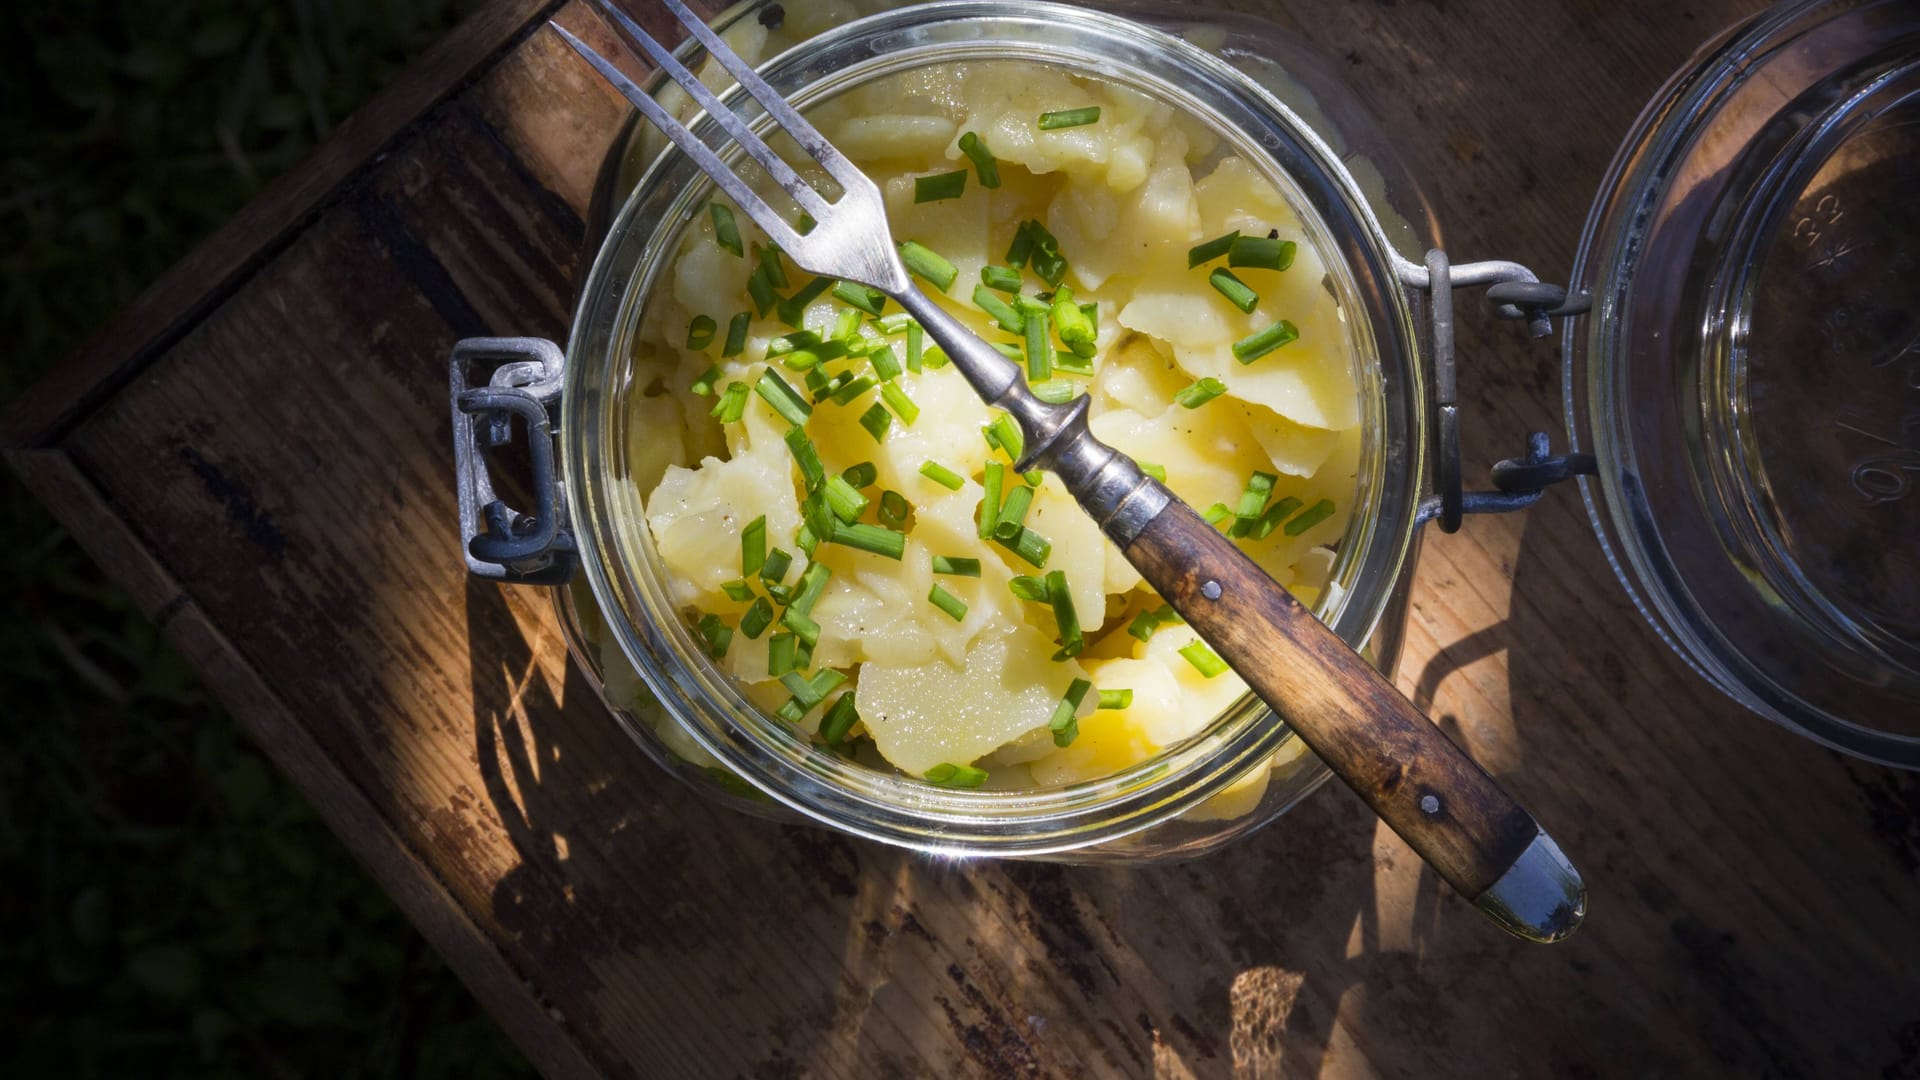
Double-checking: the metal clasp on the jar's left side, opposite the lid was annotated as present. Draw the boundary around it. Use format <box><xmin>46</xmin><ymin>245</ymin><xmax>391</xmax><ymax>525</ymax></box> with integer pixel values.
<box><xmin>449</xmin><ymin>338</ymin><xmax>578</xmax><ymax>584</ymax></box>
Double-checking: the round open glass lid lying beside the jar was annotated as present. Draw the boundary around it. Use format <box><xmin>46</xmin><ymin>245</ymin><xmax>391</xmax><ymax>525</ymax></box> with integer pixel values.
<box><xmin>1565</xmin><ymin>0</ymin><xmax>1920</xmax><ymax>767</ymax></box>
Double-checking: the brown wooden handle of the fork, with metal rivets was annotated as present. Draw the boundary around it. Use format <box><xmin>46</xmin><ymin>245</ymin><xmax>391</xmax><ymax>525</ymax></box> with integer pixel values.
<box><xmin>1127</xmin><ymin>500</ymin><xmax>1540</xmax><ymax>899</ymax></box>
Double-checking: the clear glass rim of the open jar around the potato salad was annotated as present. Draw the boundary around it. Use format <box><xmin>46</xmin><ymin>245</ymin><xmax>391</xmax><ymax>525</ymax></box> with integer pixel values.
<box><xmin>561</xmin><ymin>0</ymin><xmax>1427</xmax><ymax>855</ymax></box>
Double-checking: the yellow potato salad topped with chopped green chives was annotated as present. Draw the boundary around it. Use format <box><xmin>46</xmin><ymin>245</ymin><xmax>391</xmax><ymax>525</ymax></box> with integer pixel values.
<box><xmin>628</xmin><ymin>63</ymin><xmax>1361</xmax><ymax>799</ymax></box>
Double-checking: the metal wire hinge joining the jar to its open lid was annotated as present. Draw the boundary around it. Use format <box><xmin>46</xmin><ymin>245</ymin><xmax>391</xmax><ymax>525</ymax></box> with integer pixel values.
<box><xmin>1400</xmin><ymin>248</ymin><xmax>1596</xmax><ymax>532</ymax></box>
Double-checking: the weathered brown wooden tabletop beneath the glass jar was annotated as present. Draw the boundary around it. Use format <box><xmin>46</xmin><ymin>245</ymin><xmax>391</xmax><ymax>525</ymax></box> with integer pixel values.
<box><xmin>4</xmin><ymin>0</ymin><xmax>1920</xmax><ymax>1076</ymax></box>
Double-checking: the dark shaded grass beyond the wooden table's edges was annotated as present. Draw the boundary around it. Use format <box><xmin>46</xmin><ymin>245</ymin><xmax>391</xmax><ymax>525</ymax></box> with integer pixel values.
<box><xmin>0</xmin><ymin>0</ymin><xmax>528</xmax><ymax>1078</ymax></box>
